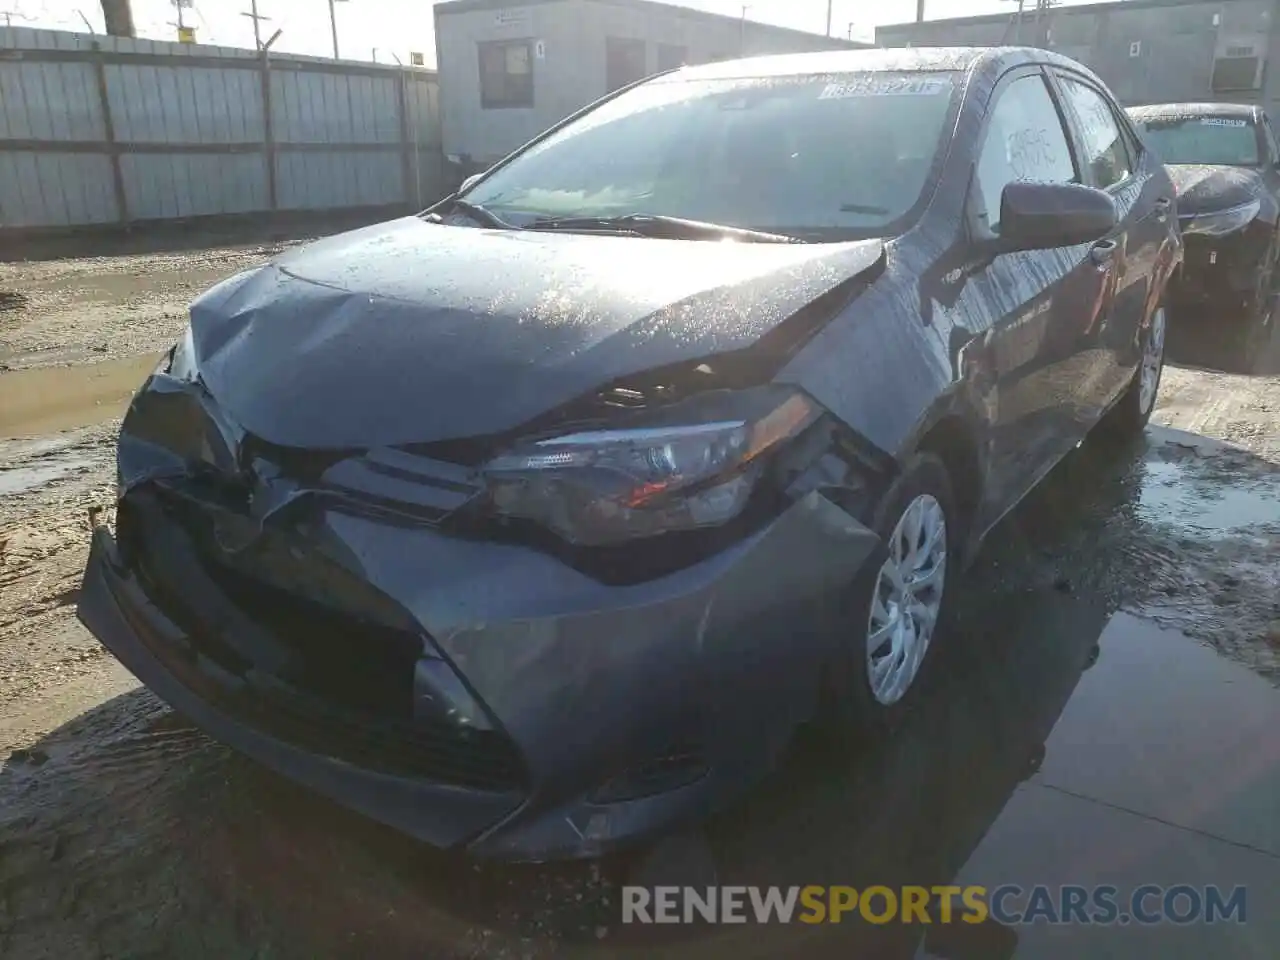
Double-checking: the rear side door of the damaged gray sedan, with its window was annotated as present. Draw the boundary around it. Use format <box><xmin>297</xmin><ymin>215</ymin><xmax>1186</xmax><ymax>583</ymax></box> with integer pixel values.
<box><xmin>1052</xmin><ymin>69</ymin><xmax>1174</xmax><ymax>426</ymax></box>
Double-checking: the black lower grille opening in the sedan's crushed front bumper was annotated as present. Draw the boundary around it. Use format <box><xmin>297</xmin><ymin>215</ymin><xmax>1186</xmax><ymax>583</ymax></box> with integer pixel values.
<box><xmin>116</xmin><ymin>492</ymin><xmax>527</xmax><ymax>790</ymax></box>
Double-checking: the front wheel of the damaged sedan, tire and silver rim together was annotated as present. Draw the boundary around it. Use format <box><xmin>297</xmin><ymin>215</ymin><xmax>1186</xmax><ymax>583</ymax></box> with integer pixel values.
<box><xmin>823</xmin><ymin>453</ymin><xmax>957</xmax><ymax>741</ymax></box>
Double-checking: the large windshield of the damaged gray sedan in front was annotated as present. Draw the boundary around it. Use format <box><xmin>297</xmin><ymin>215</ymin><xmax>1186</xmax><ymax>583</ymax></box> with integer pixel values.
<box><xmin>465</xmin><ymin>72</ymin><xmax>957</xmax><ymax>239</ymax></box>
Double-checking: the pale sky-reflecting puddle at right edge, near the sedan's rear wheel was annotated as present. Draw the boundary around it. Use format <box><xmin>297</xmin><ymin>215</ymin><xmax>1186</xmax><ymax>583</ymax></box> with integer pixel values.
<box><xmin>1138</xmin><ymin>458</ymin><xmax>1280</xmax><ymax>536</ymax></box>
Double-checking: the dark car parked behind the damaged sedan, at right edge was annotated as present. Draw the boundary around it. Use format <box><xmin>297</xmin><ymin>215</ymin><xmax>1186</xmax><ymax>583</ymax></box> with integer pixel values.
<box><xmin>1129</xmin><ymin>104</ymin><xmax>1280</xmax><ymax>351</ymax></box>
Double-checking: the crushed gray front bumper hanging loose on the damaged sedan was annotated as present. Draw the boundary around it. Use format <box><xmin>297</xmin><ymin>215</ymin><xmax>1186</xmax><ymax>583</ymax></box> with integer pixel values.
<box><xmin>79</xmin><ymin>481</ymin><xmax>882</xmax><ymax>860</ymax></box>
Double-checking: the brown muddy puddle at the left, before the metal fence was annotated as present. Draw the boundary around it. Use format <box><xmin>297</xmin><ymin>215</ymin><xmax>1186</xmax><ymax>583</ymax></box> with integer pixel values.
<box><xmin>0</xmin><ymin>353</ymin><xmax>161</xmax><ymax>439</ymax></box>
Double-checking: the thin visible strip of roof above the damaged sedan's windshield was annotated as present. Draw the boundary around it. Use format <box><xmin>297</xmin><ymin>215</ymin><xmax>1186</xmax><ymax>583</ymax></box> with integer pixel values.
<box><xmin>667</xmin><ymin>46</ymin><xmax>1097</xmax><ymax>79</ymax></box>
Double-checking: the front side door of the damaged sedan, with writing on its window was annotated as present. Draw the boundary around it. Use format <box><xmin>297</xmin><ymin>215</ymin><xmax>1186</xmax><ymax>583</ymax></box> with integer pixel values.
<box><xmin>960</xmin><ymin>67</ymin><xmax>1111</xmax><ymax>524</ymax></box>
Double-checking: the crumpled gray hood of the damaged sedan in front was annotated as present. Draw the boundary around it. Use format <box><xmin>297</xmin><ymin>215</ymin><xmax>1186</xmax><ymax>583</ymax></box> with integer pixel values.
<box><xmin>191</xmin><ymin>216</ymin><xmax>884</xmax><ymax>448</ymax></box>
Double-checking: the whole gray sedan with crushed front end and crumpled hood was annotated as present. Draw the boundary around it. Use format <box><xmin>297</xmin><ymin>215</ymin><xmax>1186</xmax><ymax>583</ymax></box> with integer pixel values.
<box><xmin>79</xmin><ymin>50</ymin><xmax>1181</xmax><ymax>860</ymax></box>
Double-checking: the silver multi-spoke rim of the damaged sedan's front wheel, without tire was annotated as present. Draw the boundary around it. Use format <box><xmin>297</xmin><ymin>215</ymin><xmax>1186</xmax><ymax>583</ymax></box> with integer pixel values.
<box><xmin>867</xmin><ymin>494</ymin><xmax>947</xmax><ymax>707</ymax></box>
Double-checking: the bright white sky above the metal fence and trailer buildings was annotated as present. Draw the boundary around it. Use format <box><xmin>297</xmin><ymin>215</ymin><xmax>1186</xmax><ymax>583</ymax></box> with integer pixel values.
<box><xmin>0</xmin><ymin>0</ymin><xmax>1100</xmax><ymax>65</ymax></box>
